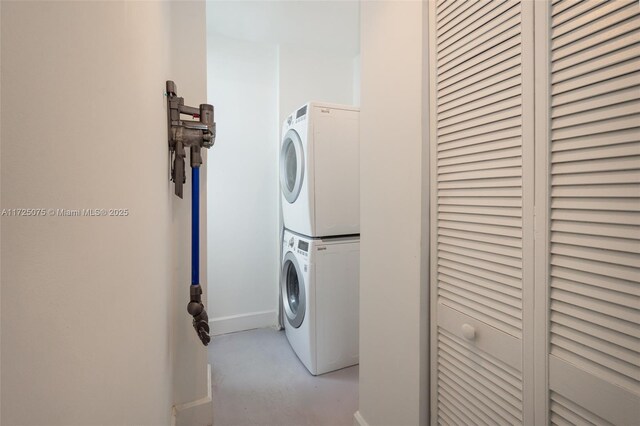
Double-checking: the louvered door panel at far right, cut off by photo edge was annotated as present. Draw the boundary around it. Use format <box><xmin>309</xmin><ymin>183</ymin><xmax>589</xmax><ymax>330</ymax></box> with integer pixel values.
<box><xmin>536</xmin><ymin>0</ymin><xmax>640</xmax><ymax>425</ymax></box>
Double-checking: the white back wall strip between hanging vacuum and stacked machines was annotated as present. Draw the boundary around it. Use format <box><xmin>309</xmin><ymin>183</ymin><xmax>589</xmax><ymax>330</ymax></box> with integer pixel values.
<box><xmin>207</xmin><ymin>34</ymin><xmax>279</xmax><ymax>333</ymax></box>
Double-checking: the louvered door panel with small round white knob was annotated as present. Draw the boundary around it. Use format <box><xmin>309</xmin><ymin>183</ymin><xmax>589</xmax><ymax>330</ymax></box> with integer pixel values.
<box><xmin>429</xmin><ymin>0</ymin><xmax>533</xmax><ymax>425</ymax></box>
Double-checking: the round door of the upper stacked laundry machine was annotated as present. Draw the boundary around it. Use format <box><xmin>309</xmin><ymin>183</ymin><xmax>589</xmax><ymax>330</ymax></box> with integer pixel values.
<box><xmin>280</xmin><ymin>129</ymin><xmax>304</xmax><ymax>204</ymax></box>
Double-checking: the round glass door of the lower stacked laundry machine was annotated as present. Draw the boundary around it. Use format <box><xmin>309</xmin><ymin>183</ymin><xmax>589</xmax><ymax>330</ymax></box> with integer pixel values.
<box><xmin>281</xmin><ymin>252</ymin><xmax>307</xmax><ymax>328</ymax></box>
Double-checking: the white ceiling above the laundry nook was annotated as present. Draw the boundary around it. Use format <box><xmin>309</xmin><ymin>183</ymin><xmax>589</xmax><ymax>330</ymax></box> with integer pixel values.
<box><xmin>207</xmin><ymin>0</ymin><xmax>360</xmax><ymax>55</ymax></box>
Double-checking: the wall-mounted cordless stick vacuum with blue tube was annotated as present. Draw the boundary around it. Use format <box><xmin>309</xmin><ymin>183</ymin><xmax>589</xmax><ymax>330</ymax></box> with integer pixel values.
<box><xmin>166</xmin><ymin>81</ymin><xmax>216</xmax><ymax>346</ymax></box>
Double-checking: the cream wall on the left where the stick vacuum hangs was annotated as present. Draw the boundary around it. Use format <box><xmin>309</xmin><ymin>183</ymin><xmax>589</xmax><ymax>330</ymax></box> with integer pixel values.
<box><xmin>0</xmin><ymin>2</ymin><xmax>207</xmax><ymax>425</ymax></box>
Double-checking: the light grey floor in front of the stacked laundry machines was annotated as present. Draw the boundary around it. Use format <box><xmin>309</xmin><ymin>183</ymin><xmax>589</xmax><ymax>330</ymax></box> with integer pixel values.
<box><xmin>209</xmin><ymin>329</ymin><xmax>358</xmax><ymax>426</ymax></box>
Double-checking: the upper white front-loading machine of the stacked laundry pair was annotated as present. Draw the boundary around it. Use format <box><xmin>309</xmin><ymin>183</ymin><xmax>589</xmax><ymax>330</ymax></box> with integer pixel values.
<box><xmin>280</xmin><ymin>102</ymin><xmax>360</xmax><ymax>237</ymax></box>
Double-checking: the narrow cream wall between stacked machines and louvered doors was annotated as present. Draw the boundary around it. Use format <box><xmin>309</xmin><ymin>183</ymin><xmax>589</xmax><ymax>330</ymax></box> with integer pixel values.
<box><xmin>355</xmin><ymin>2</ymin><xmax>428</xmax><ymax>426</ymax></box>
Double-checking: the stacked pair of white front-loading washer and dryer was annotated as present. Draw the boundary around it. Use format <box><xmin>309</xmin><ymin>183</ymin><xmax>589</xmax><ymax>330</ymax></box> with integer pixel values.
<box><xmin>280</xmin><ymin>102</ymin><xmax>360</xmax><ymax>375</ymax></box>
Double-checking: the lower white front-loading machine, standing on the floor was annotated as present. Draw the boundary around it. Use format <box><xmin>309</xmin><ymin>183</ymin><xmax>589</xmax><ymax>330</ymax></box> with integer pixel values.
<box><xmin>280</xmin><ymin>230</ymin><xmax>360</xmax><ymax>376</ymax></box>
